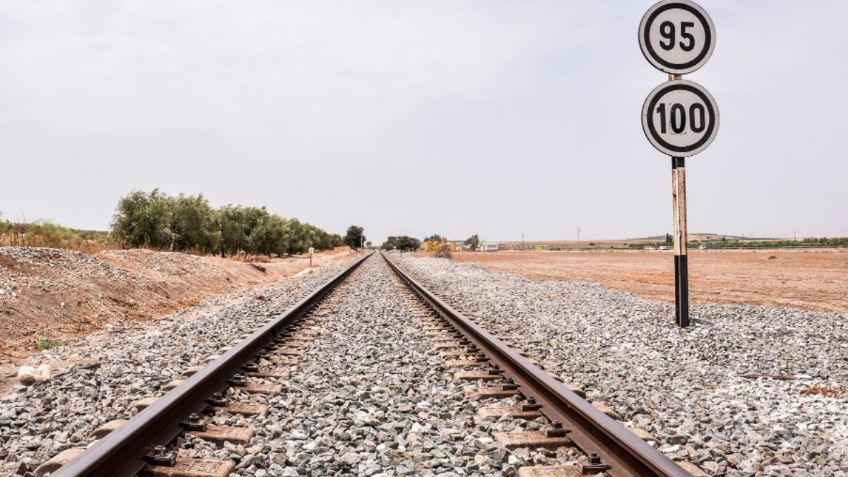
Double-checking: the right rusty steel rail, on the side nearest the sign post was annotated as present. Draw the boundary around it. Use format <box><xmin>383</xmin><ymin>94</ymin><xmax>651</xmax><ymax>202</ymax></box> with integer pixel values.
<box><xmin>380</xmin><ymin>252</ymin><xmax>692</xmax><ymax>477</ymax></box>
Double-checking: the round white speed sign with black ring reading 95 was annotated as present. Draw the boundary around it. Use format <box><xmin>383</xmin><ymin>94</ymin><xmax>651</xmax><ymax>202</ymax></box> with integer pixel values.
<box><xmin>639</xmin><ymin>0</ymin><xmax>716</xmax><ymax>75</ymax></box>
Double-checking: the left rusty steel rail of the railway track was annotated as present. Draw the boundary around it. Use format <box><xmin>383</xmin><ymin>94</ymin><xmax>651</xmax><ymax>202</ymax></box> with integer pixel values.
<box><xmin>51</xmin><ymin>254</ymin><xmax>372</xmax><ymax>477</ymax></box>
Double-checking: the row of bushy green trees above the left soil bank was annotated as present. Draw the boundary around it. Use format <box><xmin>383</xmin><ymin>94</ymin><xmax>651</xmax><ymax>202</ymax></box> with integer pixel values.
<box><xmin>112</xmin><ymin>189</ymin><xmax>344</xmax><ymax>256</ymax></box>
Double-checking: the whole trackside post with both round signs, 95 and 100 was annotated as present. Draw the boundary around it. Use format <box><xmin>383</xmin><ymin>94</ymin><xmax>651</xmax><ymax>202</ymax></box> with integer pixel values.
<box><xmin>639</xmin><ymin>0</ymin><xmax>719</xmax><ymax>327</ymax></box>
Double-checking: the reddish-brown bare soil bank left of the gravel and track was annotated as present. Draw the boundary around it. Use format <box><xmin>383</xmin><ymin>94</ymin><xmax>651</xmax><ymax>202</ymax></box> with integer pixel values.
<box><xmin>0</xmin><ymin>247</ymin><xmax>355</xmax><ymax>366</ymax></box>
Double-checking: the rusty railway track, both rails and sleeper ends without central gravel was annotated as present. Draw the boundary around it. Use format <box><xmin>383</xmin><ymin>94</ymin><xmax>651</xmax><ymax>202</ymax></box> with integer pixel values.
<box><xmin>36</xmin><ymin>251</ymin><xmax>692</xmax><ymax>477</ymax></box>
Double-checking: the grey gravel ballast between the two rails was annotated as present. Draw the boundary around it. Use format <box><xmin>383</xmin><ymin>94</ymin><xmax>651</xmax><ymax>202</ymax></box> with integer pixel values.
<box><xmin>180</xmin><ymin>256</ymin><xmax>573</xmax><ymax>477</ymax></box>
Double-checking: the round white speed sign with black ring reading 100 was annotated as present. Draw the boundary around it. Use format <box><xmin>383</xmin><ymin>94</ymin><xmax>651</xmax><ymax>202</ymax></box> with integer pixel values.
<box><xmin>642</xmin><ymin>80</ymin><xmax>719</xmax><ymax>157</ymax></box>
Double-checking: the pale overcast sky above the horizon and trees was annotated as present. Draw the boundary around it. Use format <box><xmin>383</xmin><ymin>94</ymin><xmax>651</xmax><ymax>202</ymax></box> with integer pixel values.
<box><xmin>0</xmin><ymin>0</ymin><xmax>848</xmax><ymax>241</ymax></box>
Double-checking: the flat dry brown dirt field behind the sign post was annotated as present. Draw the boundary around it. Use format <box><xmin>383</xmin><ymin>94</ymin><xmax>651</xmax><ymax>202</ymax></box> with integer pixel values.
<box><xmin>453</xmin><ymin>249</ymin><xmax>848</xmax><ymax>314</ymax></box>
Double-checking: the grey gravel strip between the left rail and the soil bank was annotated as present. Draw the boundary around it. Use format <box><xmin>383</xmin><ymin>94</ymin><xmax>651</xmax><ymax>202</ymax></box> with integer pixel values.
<box><xmin>0</xmin><ymin>257</ymin><xmax>355</xmax><ymax>475</ymax></box>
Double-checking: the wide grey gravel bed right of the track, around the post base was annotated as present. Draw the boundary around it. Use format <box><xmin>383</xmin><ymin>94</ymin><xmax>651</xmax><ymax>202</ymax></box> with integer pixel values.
<box><xmin>393</xmin><ymin>254</ymin><xmax>848</xmax><ymax>476</ymax></box>
